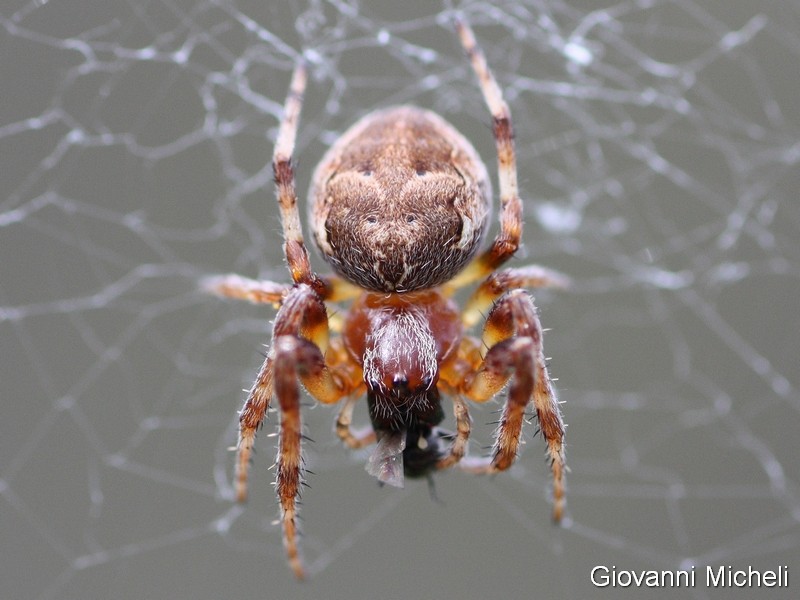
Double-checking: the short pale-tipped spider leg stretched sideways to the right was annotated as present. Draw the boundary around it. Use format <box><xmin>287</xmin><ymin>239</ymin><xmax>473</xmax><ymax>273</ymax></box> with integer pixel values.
<box><xmin>462</xmin><ymin>265</ymin><xmax>570</xmax><ymax>329</ymax></box>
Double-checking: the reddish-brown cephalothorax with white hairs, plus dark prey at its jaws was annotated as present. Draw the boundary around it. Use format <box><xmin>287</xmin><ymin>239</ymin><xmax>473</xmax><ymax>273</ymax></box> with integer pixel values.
<box><xmin>354</xmin><ymin>292</ymin><xmax>461</xmax><ymax>486</ymax></box>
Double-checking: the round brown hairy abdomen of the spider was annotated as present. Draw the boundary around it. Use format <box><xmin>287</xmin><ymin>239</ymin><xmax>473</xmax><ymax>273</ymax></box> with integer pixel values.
<box><xmin>309</xmin><ymin>106</ymin><xmax>491</xmax><ymax>292</ymax></box>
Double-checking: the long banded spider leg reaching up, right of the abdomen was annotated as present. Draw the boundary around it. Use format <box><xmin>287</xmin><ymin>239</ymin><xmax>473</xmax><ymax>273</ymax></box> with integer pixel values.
<box><xmin>445</xmin><ymin>19</ymin><xmax>522</xmax><ymax>293</ymax></box>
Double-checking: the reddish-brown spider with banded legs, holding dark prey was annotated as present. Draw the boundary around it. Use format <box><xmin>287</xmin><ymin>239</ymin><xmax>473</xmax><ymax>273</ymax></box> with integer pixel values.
<box><xmin>206</xmin><ymin>20</ymin><xmax>567</xmax><ymax>578</ymax></box>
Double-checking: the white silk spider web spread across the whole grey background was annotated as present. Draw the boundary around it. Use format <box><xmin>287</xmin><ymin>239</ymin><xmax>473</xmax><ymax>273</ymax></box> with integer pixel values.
<box><xmin>0</xmin><ymin>0</ymin><xmax>800</xmax><ymax>599</ymax></box>
